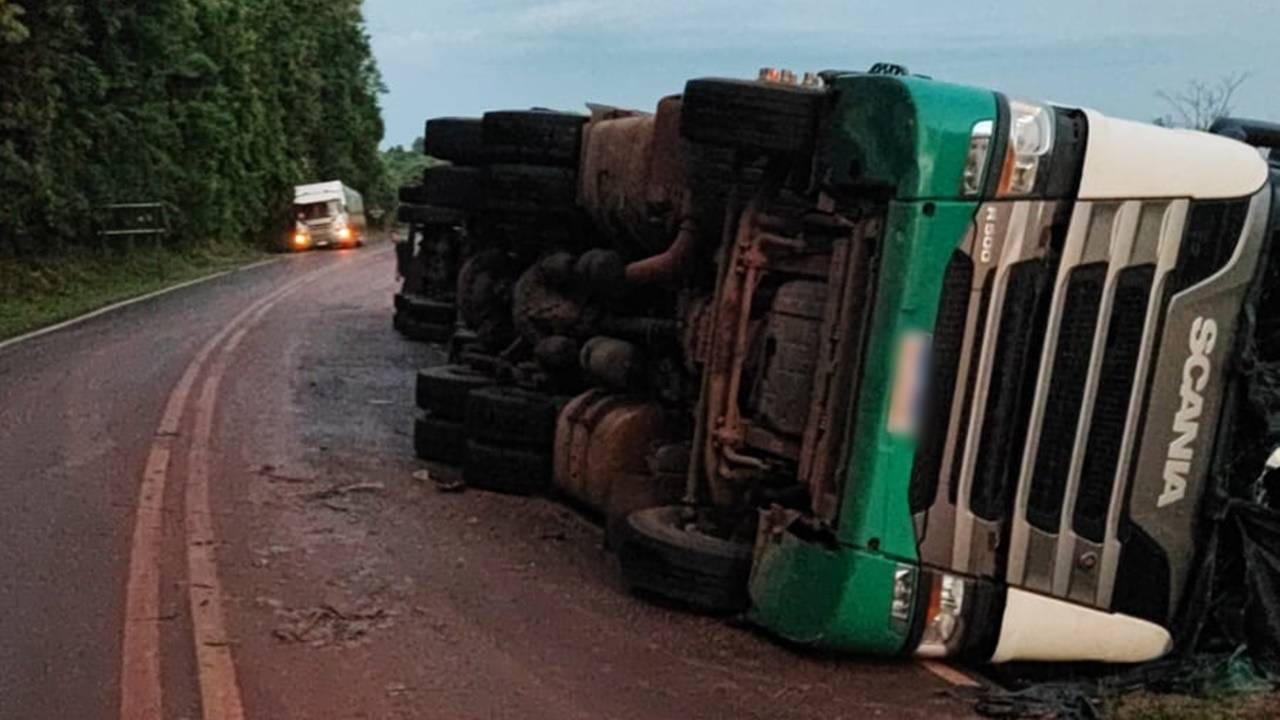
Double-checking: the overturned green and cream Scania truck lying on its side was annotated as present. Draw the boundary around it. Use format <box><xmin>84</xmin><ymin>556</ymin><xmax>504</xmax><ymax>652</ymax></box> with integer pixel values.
<box><xmin>399</xmin><ymin>68</ymin><xmax>1280</xmax><ymax>661</ymax></box>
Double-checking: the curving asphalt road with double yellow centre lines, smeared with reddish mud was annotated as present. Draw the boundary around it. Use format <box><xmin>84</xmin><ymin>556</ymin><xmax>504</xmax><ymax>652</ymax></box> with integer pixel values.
<box><xmin>0</xmin><ymin>246</ymin><xmax>972</xmax><ymax>720</ymax></box>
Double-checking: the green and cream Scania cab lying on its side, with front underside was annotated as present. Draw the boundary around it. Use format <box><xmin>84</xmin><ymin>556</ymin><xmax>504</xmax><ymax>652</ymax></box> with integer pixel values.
<box><xmin>621</xmin><ymin>73</ymin><xmax>1277</xmax><ymax>662</ymax></box>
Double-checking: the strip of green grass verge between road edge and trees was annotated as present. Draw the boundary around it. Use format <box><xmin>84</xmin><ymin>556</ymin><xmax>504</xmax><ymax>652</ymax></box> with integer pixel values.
<box><xmin>0</xmin><ymin>242</ymin><xmax>268</xmax><ymax>340</ymax></box>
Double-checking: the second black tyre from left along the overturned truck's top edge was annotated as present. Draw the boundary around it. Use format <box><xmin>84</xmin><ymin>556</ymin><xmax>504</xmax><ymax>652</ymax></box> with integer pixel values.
<box><xmin>483</xmin><ymin>110</ymin><xmax>586</xmax><ymax>168</ymax></box>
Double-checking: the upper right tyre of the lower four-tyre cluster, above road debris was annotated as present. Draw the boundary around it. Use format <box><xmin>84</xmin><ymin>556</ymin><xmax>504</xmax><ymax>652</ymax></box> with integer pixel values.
<box><xmin>466</xmin><ymin>387</ymin><xmax>563</xmax><ymax>452</ymax></box>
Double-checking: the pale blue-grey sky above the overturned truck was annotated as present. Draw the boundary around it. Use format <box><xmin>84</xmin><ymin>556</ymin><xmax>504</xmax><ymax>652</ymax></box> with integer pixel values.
<box><xmin>365</xmin><ymin>0</ymin><xmax>1280</xmax><ymax>145</ymax></box>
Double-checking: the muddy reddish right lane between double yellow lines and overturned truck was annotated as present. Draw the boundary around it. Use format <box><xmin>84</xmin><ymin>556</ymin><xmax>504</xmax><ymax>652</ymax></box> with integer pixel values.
<box><xmin>215</xmin><ymin>249</ymin><xmax>970</xmax><ymax>720</ymax></box>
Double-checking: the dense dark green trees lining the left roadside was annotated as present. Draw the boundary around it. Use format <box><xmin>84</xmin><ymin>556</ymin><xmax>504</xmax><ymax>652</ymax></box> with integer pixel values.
<box><xmin>0</xmin><ymin>0</ymin><xmax>392</xmax><ymax>255</ymax></box>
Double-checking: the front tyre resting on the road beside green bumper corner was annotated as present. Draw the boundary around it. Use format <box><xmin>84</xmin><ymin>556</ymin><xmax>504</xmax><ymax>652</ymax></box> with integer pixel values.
<box><xmin>609</xmin><ymin>506</ymin><xmax>753</xmax><ymax>614</ymax></box>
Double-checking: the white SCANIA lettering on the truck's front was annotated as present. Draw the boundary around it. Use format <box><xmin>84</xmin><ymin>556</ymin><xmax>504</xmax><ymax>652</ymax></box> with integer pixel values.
<box><xmin>1156</xmin><ymin>318</ymin><xmax>1217</xmax><ymax>507</ymax></box>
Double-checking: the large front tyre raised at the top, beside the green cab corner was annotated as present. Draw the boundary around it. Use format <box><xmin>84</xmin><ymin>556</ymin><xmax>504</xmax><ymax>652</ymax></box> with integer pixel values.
<box><xmin>680</xmin><ymin>78</ymin><xmax>828</xmax><ymax>155</ymax></box>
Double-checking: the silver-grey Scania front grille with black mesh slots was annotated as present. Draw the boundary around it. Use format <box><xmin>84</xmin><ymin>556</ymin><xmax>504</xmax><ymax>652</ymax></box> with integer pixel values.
<box><xmin>910</xmin><ymin>192</ymin><xmax>1262</xmax><ymax>623</ymax></box>
